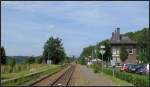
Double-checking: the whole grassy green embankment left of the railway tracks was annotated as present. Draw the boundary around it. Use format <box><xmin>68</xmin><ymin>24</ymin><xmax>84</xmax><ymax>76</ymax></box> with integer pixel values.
<box><xmin>1</xmin><ymin>64</ymin><xmax>64</xmax><ymax>86</ymax></box>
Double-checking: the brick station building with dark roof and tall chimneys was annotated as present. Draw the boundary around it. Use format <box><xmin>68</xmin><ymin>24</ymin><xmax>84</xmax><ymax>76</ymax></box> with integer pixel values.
<box><xmin>110</xmin><ymin>28</ymin><xmax>137</xmax><ymax>65</ymax></box>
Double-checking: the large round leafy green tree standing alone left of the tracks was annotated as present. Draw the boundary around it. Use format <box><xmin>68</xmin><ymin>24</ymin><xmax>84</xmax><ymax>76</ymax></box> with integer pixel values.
<box><xmin>43</xmin><ymin>37</ymin><xmax>66</xmax><ymax>64</ymax></box>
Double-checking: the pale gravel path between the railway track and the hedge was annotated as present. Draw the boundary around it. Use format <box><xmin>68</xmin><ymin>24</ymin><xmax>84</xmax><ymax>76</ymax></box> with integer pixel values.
<box><xmin>72</xmin><ymin>65</ymin><xmax>112</xmax><ymax>86</ymax></box>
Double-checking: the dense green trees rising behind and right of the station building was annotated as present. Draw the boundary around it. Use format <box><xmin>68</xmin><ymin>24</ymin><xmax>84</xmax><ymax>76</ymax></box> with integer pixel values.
<box><xmin>125</xmin><ymin>28</ymin><xmax>149</xmax><ymax>62</ymax></box>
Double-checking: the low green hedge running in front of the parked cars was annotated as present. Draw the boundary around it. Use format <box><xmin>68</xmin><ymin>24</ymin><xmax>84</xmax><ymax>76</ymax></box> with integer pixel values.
<box><xmin>103</xmin><ymin>68</ymin><xmax>149</xmax><ymax>86</ymax></box>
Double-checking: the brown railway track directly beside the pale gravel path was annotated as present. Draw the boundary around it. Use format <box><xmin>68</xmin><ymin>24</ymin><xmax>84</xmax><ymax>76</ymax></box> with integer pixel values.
<box><xmin>50</xmin><ymin>65</ymin><xmax>75</xmax><ymax>86</ymax></box>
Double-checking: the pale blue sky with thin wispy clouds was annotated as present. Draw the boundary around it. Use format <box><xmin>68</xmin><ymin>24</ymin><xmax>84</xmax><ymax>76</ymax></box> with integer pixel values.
<box><xmin>1</xmin><ymin>1</ymin><xmax>149</xmax><ymax>56</ymax></box>
